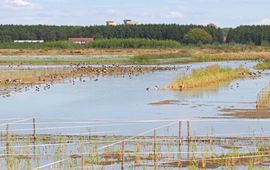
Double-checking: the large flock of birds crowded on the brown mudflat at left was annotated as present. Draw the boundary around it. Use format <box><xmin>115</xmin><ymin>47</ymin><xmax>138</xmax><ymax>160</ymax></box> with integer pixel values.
<box><xmin>0</xmin><ymin>65</ymin><xmax>176</xmax><ymax>98</ymax></box>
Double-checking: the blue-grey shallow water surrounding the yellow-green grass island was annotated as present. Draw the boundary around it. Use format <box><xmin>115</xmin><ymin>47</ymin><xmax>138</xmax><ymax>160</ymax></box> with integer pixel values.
<box><xmin>0</xmin><ymin>61</ymin><xmax>270</xmax><ymax>169</ymax></box>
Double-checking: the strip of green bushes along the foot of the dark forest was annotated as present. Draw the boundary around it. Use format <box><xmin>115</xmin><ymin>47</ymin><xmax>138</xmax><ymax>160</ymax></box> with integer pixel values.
<box><xmin>0</xmin><ymin>38</ymin><xmax>270</xmax><ymax>52</ymax></box>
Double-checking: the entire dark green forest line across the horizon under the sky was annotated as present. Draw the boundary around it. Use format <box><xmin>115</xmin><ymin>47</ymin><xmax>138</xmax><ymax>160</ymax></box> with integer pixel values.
<box><xmin>0</xmin><ymin>24</ymin><xmax>270</xmax><ymax>45</ymax></box>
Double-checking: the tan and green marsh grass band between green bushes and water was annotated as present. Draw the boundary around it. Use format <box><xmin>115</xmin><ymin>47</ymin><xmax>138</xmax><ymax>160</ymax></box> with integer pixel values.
<box><xmin>0</xmin><ymin>46</ymin><xmax>270</xmax><ymax>65</ymax></box>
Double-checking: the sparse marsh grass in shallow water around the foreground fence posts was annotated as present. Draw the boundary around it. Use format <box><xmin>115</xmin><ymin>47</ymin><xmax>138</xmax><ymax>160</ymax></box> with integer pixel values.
<box><xmin>2</xmin><ymin>120</ymin><xmax>270</xmax><ymax>169</ymax></box>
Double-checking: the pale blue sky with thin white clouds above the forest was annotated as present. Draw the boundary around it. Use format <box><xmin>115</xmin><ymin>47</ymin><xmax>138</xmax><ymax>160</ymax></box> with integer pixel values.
<box><xmin>0</xmin><ymin>0</ymin><xmax>270</xmax><ymax>27</ymax></box>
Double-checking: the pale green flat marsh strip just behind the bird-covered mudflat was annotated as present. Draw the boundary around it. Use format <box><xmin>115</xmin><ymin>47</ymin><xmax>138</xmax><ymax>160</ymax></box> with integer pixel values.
<box><xmin>0</xmin><ymin>56</ymin><xmax>189</xmax><ymax>65</ymax></box>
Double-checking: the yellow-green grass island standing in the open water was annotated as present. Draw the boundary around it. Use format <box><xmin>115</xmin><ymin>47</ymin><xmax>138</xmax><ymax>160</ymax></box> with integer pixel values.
<box><xmin>170</xmin><ymin>65</ymin><xmax>249</xmax><ymax>90</ymax></box>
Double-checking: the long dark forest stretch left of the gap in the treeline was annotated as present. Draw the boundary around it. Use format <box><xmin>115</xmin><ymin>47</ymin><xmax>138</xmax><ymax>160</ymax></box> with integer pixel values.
<box><xmin>0</xmin><ymin>24</ymin><xmax>223</xmax><ymax>43</ymax></box>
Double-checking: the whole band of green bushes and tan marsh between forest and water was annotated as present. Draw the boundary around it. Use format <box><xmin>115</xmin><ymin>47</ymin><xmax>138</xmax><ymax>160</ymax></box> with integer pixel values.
<box><xmin>0</xmin><ymin>42</ymin><xmax>270</xmax><ymax>65</ymax></box>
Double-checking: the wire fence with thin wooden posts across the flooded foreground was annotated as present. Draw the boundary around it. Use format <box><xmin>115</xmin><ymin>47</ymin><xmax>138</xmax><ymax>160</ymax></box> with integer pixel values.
<box><xmin>0</xmin><ymin>118</ymin><xmax>270</xmax><ymax>170</ymax></box>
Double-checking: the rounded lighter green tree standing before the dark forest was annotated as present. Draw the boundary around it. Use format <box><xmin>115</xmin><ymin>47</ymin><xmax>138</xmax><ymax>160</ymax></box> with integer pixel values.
<box><xmin>185</xmin><ymin>28</ymin><xmax>213</xmax><ymax>44</ymax></box>
